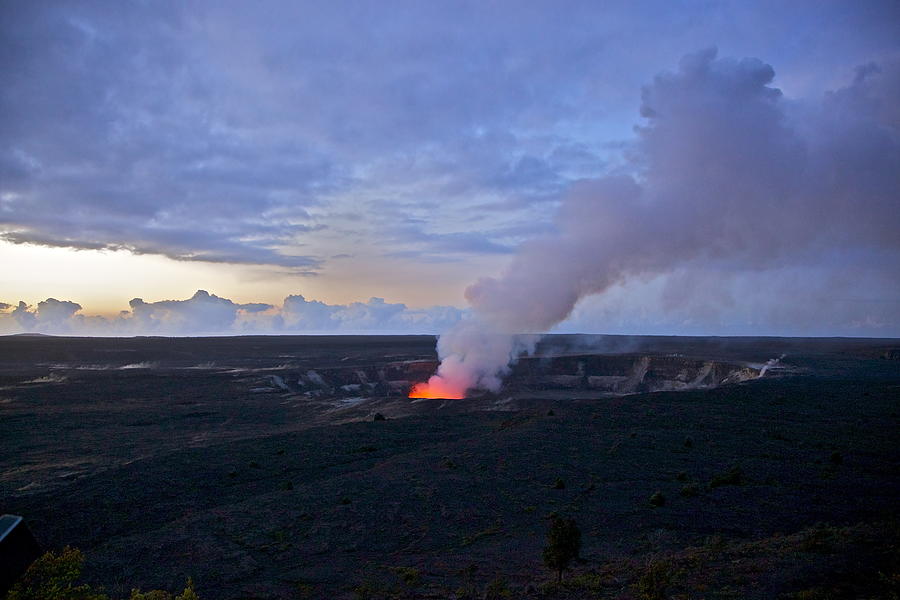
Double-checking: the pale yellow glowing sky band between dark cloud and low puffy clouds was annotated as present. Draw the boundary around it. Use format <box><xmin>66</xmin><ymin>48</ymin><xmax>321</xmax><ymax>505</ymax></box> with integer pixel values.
<box><xmin>0</xmin><ymin>241</ymin><xmax>488</xmax><ymax>316</ymax></box>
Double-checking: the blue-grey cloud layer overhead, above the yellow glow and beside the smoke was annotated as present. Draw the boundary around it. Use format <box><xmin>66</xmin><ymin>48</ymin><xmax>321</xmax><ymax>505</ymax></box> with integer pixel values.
<box><xmin>0</xmin><ymin>1</ymin><xmax>896</xmax><ymax>273</ymax></box>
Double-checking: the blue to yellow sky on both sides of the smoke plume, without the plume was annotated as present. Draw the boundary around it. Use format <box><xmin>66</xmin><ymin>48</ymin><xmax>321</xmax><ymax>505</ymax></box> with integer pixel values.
<box><xmin>0</xmin><ymin>1</ymin><xmax>900</xmax><ymax>335</ymax></box>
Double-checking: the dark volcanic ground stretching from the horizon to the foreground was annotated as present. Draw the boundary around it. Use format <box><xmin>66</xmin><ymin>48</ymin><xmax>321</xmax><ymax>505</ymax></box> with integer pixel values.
<box><xmin>0</xmin><ymin>336</ymin><xmax>900</xmax><ymax>600</ymax></box>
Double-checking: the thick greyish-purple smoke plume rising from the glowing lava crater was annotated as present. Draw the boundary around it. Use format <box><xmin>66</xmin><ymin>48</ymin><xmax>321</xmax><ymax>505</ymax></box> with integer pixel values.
<box><xmin>418</xmin><ymin>49</ymin><xmax>900</xmax><ymax>395</ymax></box>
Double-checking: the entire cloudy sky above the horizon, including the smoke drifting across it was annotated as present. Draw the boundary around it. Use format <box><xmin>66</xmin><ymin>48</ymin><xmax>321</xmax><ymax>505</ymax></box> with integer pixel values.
<box><xmin>0</xmin><ymin>0</ymin><xmax>900</xmax><ymax>336</ymax></box>
